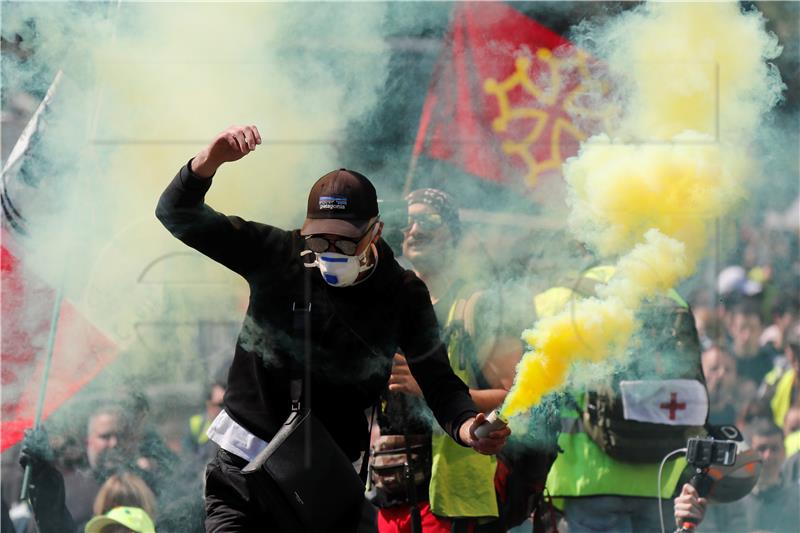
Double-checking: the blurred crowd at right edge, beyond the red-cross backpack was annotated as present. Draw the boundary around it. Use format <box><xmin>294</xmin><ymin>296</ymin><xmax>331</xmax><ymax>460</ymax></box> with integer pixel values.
<box><xmin>675</xmin><ymin>216</ymin><xmax>800</xmax><ymax>531</ymax></box>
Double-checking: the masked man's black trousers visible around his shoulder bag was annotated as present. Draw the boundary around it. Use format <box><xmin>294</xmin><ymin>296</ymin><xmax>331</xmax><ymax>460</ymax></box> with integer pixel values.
<box><xmin>205</xmin><ymin>449</ymin><xmax>377</xmax><ymax>533</ymax></box>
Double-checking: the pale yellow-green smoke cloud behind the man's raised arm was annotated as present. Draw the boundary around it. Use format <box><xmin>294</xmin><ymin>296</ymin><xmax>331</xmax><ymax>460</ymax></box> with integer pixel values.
<box><xmin>2</xmin><ymin>2</ymin><xmax>389</xmax><ymax>384</ymax></box>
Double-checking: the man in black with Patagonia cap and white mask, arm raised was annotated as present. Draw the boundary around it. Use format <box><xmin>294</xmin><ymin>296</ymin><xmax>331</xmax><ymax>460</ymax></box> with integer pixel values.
<box><xmin>156</xmin><ymin>122</ymin><xmax>509</xmax><ymax>531</ymax></box>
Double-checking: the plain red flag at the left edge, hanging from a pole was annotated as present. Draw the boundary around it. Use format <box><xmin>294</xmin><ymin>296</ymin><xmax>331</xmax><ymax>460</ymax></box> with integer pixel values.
<box><xmin>0</xmin><ymin>231</ymin><xmax>117</xmax><ymax>451</ymax></box>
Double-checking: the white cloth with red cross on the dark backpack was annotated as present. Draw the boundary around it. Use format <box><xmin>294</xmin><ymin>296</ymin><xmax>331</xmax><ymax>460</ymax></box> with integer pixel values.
<box><xmin>619</xmin><ymin>379</ymin><xmax>708</xmax><ymax>426</ymax></box>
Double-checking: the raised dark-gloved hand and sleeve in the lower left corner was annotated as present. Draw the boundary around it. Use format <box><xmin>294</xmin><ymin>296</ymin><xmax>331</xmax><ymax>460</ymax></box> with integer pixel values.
<box><xmin>19</xmin><ymin>427</ymin><xmax>76</xmax><ymax>533</ymax></box>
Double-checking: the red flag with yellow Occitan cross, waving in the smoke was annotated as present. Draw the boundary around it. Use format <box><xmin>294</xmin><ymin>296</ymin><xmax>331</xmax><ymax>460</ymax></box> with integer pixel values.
<box><xmin>414</xmin><ymin>2</ymin><xmax>612</xmax><ymax>186</ymax></box>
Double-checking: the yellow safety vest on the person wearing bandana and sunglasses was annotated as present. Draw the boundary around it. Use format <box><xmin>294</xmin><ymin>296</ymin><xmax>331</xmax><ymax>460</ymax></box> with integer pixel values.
<box><xmin>428</xmin><ymin>294</ymin><xmax>498</xmax><ymax>518</ymax></box>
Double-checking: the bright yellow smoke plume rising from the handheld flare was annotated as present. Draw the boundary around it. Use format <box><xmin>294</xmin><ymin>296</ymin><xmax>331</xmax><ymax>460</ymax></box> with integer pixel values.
<box><xmin>503</xmin><ymin>3</ymin><xmax>782</xmax><ymax>416</ymax></box>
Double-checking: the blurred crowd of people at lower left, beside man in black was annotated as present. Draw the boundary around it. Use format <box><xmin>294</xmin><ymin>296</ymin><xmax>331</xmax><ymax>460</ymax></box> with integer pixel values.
<box><xmin>3</xmin><ymin>381</ymin><xmax>216</xmax><ymax>533</ymax></box>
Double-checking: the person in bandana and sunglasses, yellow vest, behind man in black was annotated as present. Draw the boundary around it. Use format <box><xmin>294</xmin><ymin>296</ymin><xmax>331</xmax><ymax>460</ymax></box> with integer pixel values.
<box><xmin>372</xmin><ymin>189</ymin><xmax>522</xmax><ymax>533</ymax></box>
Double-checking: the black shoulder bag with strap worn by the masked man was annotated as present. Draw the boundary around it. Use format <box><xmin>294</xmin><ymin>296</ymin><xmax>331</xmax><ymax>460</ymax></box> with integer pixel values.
<box><xmin>242</xmin><ymin>276</ymin><xmax>367</xmax><ymax>533</ymax></box>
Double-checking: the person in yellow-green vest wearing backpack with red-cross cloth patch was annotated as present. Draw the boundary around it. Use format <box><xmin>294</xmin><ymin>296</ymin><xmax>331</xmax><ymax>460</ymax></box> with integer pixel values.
<box><xmin>534</xmin><ymin>266</ymin><xmax>708</xmax><ymax>533</ymax></box>
